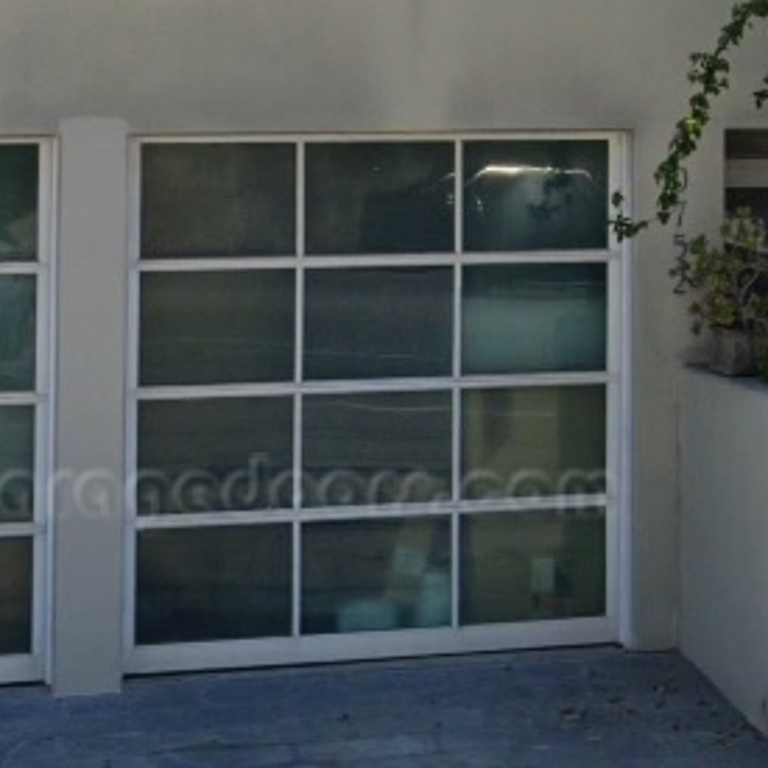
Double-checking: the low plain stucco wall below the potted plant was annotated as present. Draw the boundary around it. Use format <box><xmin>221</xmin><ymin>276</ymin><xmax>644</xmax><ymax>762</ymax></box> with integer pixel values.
<box><xmin>680</xmin><ymin>371</ymin><xmax>768</xmax><ymax>732</ymax></box>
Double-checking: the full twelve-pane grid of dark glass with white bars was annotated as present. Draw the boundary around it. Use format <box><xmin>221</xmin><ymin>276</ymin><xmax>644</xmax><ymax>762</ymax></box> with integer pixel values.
<box><xmin>128</xmin><ymin>135</ymin><xmax>620</xmax><ymax>664</ymax></box>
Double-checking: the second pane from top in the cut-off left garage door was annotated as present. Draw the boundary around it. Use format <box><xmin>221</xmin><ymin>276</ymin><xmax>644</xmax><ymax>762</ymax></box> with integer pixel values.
<box><xmin>0</xmin><ymin>275</ymin><xmax>36</xmax><ymax>392</ymax></box>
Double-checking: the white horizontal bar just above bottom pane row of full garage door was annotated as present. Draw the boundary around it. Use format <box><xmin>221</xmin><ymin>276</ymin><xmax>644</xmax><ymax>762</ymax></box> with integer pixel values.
<box><xmin>136</xmin><ymin>494</ymin><xmax>608</xmax><ymax>530</ymax></box>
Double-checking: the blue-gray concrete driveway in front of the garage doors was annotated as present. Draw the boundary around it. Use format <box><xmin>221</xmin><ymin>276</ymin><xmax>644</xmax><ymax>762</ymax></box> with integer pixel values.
<box><xmin>0</xmin><ymin>648</ymin><xmax>768</xmax><ymax>768</ymax></box>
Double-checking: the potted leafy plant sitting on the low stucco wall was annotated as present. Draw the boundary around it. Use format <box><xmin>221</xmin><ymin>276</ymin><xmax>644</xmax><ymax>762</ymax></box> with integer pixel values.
<box><xmin>670</xmin><ymin>209</ymin><xmax>768</xmax><ymax>376</ymax></box>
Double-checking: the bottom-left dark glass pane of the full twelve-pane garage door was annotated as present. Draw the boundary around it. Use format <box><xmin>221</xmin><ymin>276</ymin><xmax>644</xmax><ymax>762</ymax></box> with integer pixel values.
<box><xmin>136</xmin><ymin>525</ymin><xmax>292</xmax><ymax>645</ymax></box>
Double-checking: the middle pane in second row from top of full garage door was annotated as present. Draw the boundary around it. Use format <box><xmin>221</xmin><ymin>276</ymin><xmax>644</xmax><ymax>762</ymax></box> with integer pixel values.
<box><xmin>304</xmin><ymin>268</ymin><xmax>453</xmax><ymax>379</ymax></box>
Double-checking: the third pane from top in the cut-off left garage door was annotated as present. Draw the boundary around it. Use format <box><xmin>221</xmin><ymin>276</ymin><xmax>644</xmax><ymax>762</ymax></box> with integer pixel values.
<box><xmin>0</xmin><ymin>405</ymin><xmax>35</xmax><ymax>520</ymax></box>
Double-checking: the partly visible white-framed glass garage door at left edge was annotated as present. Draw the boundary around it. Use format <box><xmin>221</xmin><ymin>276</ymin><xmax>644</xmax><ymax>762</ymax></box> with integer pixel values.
<box><xmin>0</xmin><ymin>142</ymin><xmax>49</xmax><ymax>682</ymax></box>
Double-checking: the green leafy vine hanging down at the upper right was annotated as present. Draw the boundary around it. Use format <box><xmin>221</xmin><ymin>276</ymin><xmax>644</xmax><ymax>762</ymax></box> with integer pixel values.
<box><xmin>611</xmin><ymin>0</ymin><xmax>768</xmax><ymax>240</ymax></box>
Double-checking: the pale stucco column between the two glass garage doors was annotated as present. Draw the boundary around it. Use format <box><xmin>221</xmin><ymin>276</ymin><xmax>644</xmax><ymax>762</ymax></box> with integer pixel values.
<box><xmin>51</xmin><ymin>118</ymin><xmax>128</xmax><ymax>695</ymax></box>
